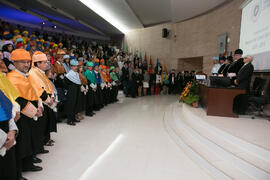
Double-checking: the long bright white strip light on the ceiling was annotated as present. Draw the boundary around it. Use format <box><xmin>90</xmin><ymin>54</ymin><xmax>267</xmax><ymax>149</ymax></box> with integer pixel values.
<box><xmin>80</xmin><ymin>0</ymin><xmax>129</xmax><ymax>34</ymax></box>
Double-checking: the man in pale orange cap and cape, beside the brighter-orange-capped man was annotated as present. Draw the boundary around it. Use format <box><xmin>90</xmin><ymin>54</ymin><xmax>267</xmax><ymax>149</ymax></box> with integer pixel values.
<box><xmin>28</xmin><ymin>51</ymin><xmax>57</xmax><ymax>148</ymax></box>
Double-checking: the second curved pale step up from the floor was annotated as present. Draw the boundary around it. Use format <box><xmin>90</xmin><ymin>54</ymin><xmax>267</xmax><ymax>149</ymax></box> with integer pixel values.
<box><xmin>179</xmin><ymin>103</ymin><xmax>270</xmax><ymax>173</ymax></box>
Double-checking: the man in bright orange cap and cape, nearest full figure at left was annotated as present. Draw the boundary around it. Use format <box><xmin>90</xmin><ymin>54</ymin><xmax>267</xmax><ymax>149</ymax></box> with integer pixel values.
<box><xmin>7</xmin><ymin>49</ymin><xmax>42</xmax><ymax>179</ymax></box>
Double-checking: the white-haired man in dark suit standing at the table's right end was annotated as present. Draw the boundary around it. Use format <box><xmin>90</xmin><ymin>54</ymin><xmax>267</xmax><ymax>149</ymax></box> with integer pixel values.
<box><xmin>234</xmin><ymin>55</ymin><xmax>254</xmax><ymax>114</ymax></box>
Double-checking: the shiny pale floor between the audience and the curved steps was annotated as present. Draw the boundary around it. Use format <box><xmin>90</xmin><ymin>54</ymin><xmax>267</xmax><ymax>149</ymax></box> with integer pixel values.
<box><xmin>24</xmin><ymin>96</ymin><xmax>212</xmax><ymax>180</ymax></box>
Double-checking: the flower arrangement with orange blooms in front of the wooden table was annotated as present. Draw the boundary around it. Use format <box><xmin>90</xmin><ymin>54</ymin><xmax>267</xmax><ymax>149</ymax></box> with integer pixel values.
<box><xmin>179</xmin><ymin>81</ymin><xmax>199</xmax><ymax>105</ymax></box>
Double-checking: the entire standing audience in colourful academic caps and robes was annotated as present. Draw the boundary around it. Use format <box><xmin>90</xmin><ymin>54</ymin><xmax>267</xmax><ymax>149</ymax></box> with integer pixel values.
<box><xmin>0</xmin><ymin>22</ymin><xmax>194</xmax><ymax>180</ymax></box>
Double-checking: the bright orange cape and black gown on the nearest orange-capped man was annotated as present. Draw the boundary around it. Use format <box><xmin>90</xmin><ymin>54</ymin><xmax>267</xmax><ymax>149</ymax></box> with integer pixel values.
<box><xmin>7</xmin><ymin>70</ymin><xmax>41</xmax><ymax>177</ymax></box>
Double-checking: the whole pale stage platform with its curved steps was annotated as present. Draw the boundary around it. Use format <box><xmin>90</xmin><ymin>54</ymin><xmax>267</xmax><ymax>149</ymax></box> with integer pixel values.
<box><xmin>164</xmin><ymin>102</ymin><xmax>270</xmax><ymax>180</ymax></box>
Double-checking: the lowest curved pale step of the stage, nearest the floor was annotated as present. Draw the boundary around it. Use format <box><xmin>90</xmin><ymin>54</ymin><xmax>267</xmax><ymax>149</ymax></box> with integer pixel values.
<box><xmin>165</xmin><ymin>104</ymin><xmax>270</xmax><ymax>180</ymax></box>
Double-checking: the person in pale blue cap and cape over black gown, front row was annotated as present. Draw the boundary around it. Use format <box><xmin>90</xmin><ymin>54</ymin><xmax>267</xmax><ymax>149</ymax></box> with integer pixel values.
<box><xmin>65</xmin><ymin>59</ymin><xmax>81</xmax><ymax>126</ymax></box>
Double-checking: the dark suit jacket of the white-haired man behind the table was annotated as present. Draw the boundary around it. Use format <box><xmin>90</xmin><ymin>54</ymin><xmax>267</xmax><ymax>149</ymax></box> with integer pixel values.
<box><xmin>236</xmin><ymin>63</ymin><xmax>254</xmax><ymax>93</ymax></box>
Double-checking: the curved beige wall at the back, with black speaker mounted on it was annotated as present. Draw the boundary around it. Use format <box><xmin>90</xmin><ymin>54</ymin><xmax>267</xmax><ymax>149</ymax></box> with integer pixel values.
<box><xmin>125</xmin><ymin>0</ymin><xmax>243</xmax><ymax>73</ymax></box>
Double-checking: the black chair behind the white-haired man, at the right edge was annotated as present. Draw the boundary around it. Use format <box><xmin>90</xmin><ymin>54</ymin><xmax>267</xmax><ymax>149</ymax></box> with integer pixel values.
<box><xmin>248</xmin><ymin>77</ymin><xmax>270</xmax><ymax>120</ymax></box>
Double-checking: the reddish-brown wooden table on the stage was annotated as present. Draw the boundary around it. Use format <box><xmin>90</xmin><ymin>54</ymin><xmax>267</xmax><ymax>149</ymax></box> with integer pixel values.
<box><xmin>199</xmin><ymin>84</ymin><xmax>246</xmax><ymax>117</ymax></box>
